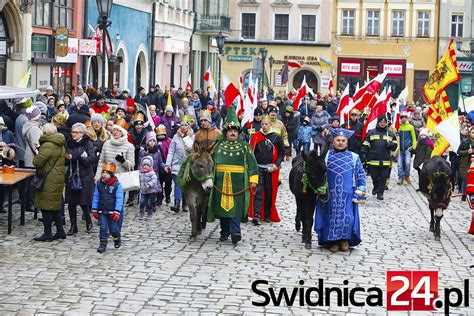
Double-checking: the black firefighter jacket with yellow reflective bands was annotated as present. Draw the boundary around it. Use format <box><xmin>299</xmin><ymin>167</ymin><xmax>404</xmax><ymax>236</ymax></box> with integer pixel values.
<box><xmin>361</xmin><ymin>125</ymin><xmax>398</xmax><ymax>167</ymax></box>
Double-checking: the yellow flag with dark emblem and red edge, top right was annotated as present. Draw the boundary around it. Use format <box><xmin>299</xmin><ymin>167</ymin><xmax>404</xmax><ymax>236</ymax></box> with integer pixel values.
<box><xmin>423</xmin><ymin>39</ymin><xmax>461</xmax><ymax>104</ymax></box>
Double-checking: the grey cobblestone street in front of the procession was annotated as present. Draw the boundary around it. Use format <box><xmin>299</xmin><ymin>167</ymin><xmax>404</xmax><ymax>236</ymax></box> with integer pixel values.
<box><xmin>0</xmin><ymin>163</ymin><xmax>474</xmax><ymax>315</ymax></box>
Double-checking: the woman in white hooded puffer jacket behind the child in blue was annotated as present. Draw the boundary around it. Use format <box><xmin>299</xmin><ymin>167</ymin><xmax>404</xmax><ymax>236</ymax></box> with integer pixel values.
<box><xmin>95</xmin><ymin>125</ymin><xmax>135</xmax><ymax>180</ymax></box>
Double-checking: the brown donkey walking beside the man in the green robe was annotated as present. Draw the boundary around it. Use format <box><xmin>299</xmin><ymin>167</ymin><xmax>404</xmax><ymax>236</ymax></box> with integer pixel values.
<box><xmin>180</xmin><ymin>143</ymin><xmax>214</xmax><ymax>240</ymax></box>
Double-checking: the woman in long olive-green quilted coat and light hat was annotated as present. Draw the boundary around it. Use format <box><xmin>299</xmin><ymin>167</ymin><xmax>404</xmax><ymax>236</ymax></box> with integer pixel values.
<box><xmin>33</xmin><ymin>124</ymin><xmax>66</xmax><ymax>241</ymax></box>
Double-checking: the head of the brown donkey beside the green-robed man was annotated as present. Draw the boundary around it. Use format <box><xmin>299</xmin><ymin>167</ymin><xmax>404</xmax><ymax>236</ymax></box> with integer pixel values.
<box><xmin>192</xmin><ymin>143</ymin><xmax>214</xmax><ymax>191</ymax></box>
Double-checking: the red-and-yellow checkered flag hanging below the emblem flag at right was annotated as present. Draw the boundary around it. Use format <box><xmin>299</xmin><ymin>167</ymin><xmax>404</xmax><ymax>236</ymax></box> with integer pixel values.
<box><xmin>426</xmin><ymin>90</ymin><xmax>452</xmax><ymax>157</ymax></box>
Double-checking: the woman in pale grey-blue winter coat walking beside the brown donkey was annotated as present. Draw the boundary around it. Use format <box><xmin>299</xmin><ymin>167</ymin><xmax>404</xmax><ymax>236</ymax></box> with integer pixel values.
<box><xmin>165</xmin><ymin>122</ymin><xmax>194</xmax><ymax>213</ymax></box>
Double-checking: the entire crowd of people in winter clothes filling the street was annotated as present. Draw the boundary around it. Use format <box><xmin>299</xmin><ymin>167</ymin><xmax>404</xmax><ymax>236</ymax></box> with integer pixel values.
<box><xmin>0</xmin><ymin>81</ymin><xmax>474</xmax><ymax>252</ymax></box>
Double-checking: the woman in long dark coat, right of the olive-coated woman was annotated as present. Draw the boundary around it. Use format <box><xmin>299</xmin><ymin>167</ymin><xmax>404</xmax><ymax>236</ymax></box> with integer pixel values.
<box><xmin>66</xmin><ymin>123</ymin><xmax>98</xmax><ymax>236</ymax></box>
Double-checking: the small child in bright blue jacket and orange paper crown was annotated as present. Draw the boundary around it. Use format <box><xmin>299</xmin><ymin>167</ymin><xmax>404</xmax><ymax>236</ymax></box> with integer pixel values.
<box><xmin>92</xmin><ymin>162</ymin><xmax>123</xmax><ymax>253</ymax></box>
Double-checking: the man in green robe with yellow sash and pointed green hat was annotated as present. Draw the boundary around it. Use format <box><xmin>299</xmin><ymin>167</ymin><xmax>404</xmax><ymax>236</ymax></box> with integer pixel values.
<box><xmin>207</xmin><ymin>106</ymin><xmax>258</xmax><ymax>245</ymax></box>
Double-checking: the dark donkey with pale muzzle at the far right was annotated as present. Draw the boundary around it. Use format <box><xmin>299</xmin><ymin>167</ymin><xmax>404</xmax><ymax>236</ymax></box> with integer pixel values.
<box><xmin>419</xmin><ymin>156</ymin><xmax>454</xmax><ymax>241</ymax></box>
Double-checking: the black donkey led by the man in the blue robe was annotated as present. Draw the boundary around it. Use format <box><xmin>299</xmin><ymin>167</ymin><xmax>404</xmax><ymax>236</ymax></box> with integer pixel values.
<box><xmin>290</xmin><ymin>150</ymin><xmax>328</xmax><ymax>249</ymax></box>
